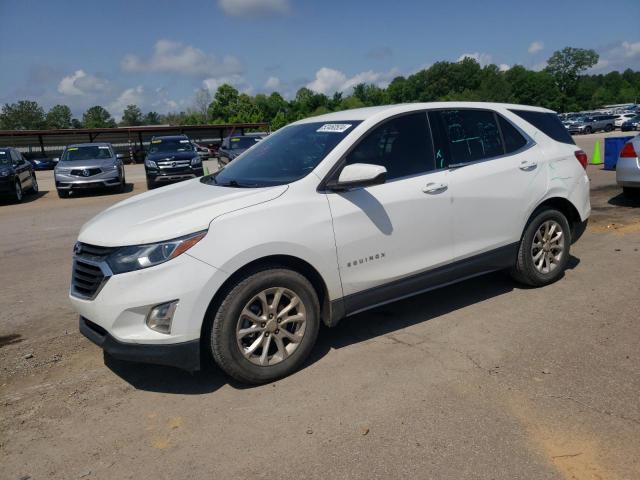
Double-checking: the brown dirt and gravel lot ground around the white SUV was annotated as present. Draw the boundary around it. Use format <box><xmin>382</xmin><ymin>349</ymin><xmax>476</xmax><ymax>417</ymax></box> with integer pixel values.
<box><xmin>0</xmin><ymin>146</ymin><xmax>640</xmax><ymax>480</ymax></box>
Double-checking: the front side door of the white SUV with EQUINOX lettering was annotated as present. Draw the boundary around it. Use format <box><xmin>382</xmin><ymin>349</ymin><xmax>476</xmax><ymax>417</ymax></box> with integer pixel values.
<box><xmin>327</xmin><ymin>112</ymin><xmax>453</xmax><ymax>302</ymax></box>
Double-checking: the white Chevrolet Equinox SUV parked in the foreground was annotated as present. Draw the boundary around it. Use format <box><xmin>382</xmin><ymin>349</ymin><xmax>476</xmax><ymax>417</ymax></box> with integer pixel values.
<box><xmin>70</xmin><ymin>102</ymin><xmax>590</xmax><ymax>383</ymax></box>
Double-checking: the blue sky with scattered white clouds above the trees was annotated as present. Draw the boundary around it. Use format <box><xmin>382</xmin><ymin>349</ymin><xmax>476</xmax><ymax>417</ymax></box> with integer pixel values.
<box><xmin>0</xmin><ymin>0</ymin><xmax>640</xmax><ymax>118</ymax></box>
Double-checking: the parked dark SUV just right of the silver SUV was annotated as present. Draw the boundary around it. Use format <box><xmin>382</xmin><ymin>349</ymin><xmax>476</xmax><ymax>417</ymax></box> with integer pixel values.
<box><xmin>144</xmin><ymin>135</ymin><xmax>204</xmax><ymax>190</ymax></box>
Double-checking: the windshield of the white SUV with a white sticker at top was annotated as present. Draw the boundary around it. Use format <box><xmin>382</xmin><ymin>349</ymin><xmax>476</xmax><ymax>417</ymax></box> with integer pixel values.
<box><xmin>209</xmin><ymin>121</ymin><xmax>360</xmax><ymax>188</ymax></box>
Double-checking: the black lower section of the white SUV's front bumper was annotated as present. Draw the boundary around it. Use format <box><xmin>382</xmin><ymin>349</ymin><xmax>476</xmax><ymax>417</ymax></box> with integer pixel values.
<box><xmin>80</xmin><ymin>316</ymin><xmax>200</xmax><ymax>372</ymax></box>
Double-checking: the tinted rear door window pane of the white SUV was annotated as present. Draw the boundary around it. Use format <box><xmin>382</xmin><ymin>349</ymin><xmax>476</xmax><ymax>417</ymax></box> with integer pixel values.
<box><xmin>429</xmin><ymin>110</ymin><xmax>504</xmax><ymax>168</ymax></box>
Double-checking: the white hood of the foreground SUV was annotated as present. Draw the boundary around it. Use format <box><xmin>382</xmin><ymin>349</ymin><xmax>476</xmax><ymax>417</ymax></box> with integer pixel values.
<box><xmin>78</xmin><ymin>179</ymin><xmax>288</xmax><ymax>247</ymax></box>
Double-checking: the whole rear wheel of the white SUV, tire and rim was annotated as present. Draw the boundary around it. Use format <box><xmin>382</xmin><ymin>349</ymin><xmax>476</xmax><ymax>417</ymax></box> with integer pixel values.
<box><xmin>511</xmin><ymin>209</ymin><xmax>571</xmax><ymax>287</ymax></box>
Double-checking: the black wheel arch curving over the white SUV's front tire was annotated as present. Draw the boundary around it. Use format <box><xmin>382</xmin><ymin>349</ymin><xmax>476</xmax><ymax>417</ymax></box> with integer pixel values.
<box><xmin>200</xmin><ymin>255</ymin><xmax>332</xmax><ymax>362</ymax></box>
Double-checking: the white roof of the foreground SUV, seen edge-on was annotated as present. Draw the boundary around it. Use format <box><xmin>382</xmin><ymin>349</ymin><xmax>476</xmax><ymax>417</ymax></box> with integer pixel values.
<box><xmin>297</xmin><ymin>102</ymin><xmax>555</xmax><ymax>123</ymax></box>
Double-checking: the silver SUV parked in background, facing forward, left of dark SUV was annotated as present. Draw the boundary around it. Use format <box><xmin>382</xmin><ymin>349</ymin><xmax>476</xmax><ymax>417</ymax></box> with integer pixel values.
<box><xmin>54</xmin><ymin>143</ymin><xmax>126</xmax><ymax>198</ymax></box>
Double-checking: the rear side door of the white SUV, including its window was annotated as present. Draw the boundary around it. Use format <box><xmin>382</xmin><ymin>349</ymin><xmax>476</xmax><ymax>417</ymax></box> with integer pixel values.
<box><xmin>429</xmin><ymin>109</ymin><xmax>547</xmax><ymax>260</ymax></box>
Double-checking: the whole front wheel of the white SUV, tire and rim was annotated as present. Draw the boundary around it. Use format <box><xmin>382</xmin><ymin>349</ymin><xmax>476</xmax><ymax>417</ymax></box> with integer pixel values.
<box><xmin>208</xmin><ymin>268</ymin><xmax>320</xmax><ymax>384</ymax></box>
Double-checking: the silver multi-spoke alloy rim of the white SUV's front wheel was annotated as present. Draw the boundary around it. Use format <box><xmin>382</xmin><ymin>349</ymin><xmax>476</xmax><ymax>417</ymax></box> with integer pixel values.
<box><xmin>236</xmin><ymin>287</ymin><xmax>307</xmax><ymax>366</ymax></box>
